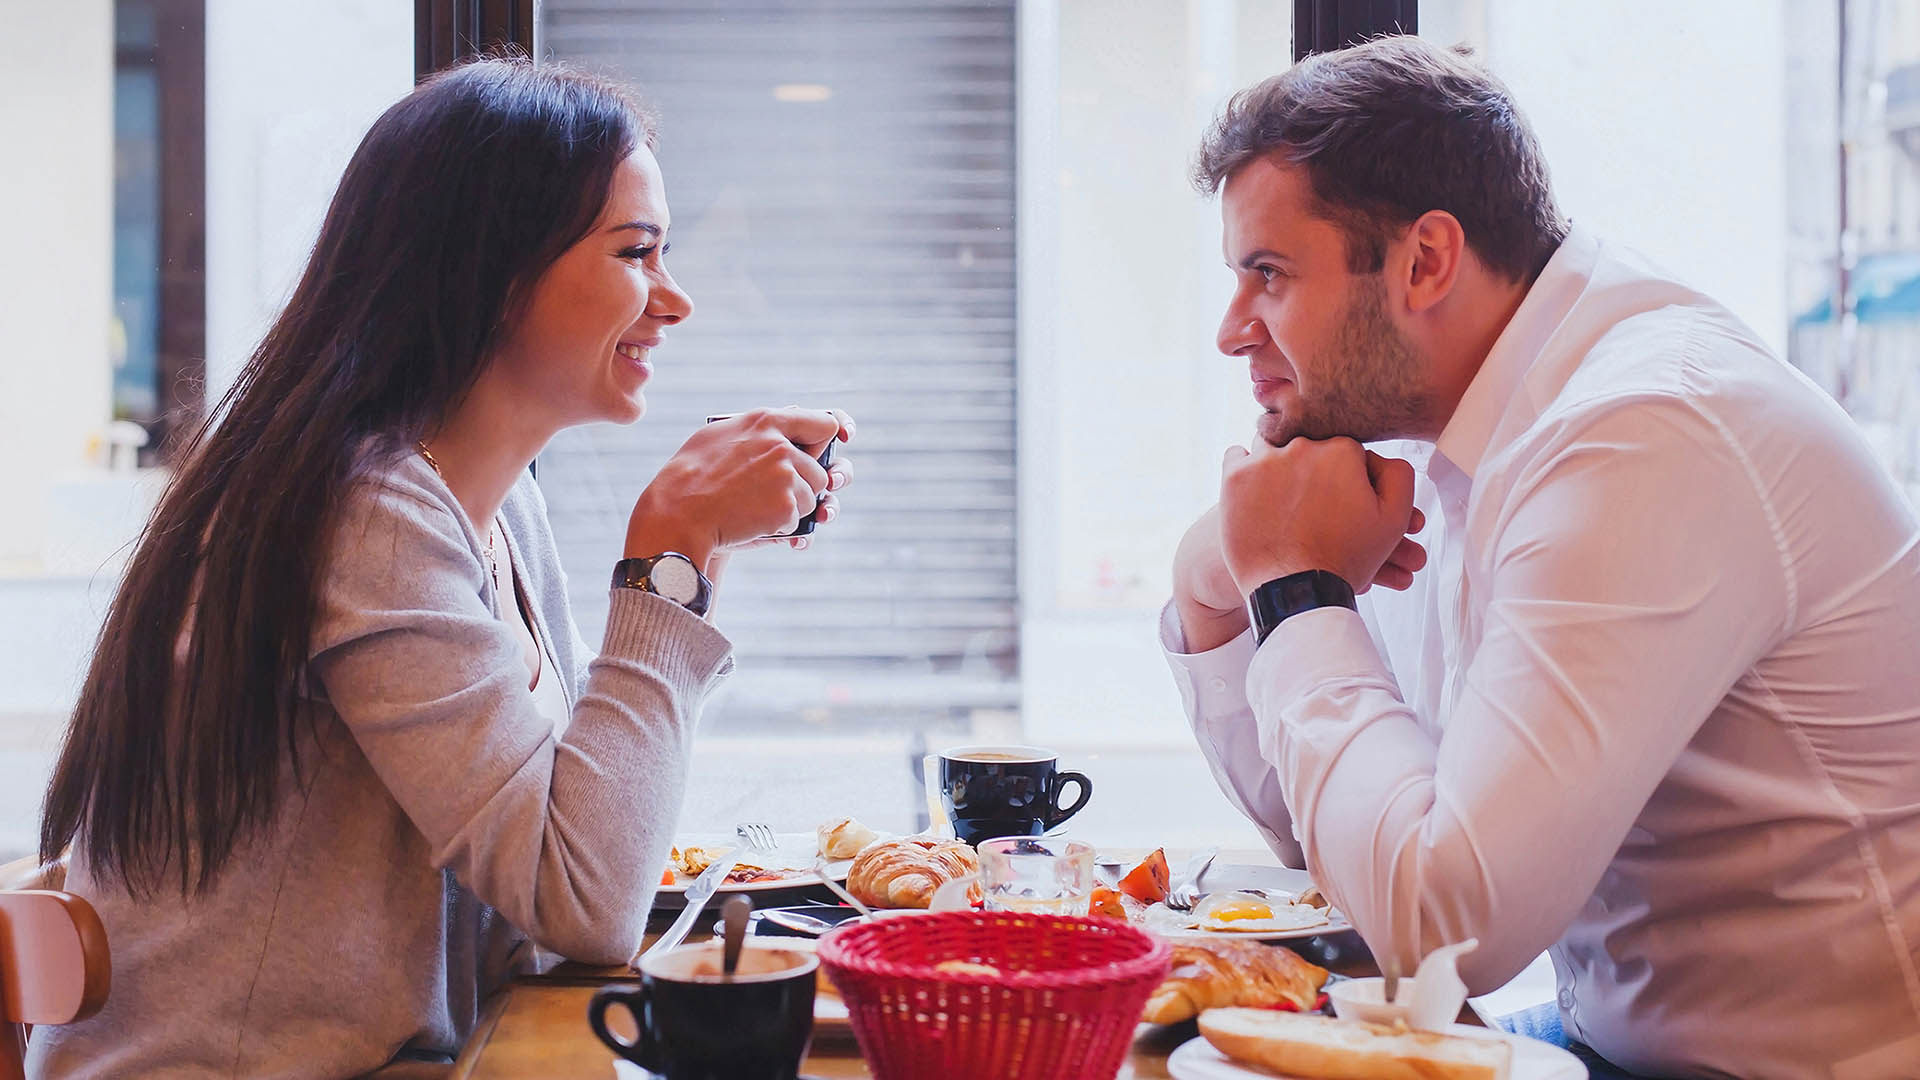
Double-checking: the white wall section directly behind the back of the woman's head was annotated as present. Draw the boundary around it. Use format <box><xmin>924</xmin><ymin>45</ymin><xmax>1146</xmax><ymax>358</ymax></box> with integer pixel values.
<box><xmin>207</xmin><ymin>0</ymin><xmax>413</xmax><ymax>402</ymax></box>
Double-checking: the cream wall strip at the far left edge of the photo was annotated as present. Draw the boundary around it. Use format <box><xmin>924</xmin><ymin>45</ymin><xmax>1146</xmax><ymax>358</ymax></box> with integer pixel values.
<box><xmin>0</xmin><ymin>0</ymin><xmax>113</xmax><ymax>575</ymax></box>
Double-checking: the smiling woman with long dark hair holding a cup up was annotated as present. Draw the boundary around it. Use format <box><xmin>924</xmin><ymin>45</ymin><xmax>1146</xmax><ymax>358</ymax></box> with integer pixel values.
<box><xmin>29</xmin><ymin>61</ymin><xmax>852</xmax><ymax>1076</ymax></box>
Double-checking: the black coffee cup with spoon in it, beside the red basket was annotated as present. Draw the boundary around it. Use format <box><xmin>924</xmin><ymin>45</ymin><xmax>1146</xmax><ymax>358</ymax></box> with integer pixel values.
<box><xmin>588</xmin><ymin>942</ymin><xmax>820</xmax><ymax>1080</ymax></box>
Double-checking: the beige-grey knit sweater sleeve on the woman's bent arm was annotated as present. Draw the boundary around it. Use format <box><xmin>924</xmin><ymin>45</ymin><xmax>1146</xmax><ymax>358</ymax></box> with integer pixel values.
<box><xmin>311</xmin><ymin>474</ymin><xmax>732</xmax><ymax>963</ymax></box>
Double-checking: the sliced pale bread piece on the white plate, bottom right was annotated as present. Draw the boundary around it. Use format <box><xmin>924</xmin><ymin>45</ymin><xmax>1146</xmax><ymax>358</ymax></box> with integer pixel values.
<box><xmin>1200</xmin><ymin>1009</ymin><xmax>1513</xmax><ymax>1080</ymax></box>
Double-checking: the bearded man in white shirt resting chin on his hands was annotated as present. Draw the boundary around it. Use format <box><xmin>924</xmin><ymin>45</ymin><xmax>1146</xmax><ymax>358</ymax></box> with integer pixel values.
<box><xmin>1162</xmin><ymin>38</ymin><xmax>1920</xmax><ymax>1080</ymax></box>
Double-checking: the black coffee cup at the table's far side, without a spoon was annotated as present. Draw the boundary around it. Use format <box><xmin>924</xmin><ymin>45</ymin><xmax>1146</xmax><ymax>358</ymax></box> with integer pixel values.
<box><xmin>941</xmin><ymin>734</ymin><xmax>1092</xmax><ymax>844</ymax></box>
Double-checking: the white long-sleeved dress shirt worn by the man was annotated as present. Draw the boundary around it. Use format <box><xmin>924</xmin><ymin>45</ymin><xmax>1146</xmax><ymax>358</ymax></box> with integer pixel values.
<box><xmin>1162</xmin><ymin>231</ymin><xmax>1920</xmax><ymax>1080</ymax></box>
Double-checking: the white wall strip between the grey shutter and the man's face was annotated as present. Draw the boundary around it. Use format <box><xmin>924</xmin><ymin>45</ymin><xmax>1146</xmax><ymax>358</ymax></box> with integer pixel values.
<box><xmin>1020</xmin><ymin>0</ymin><xmax>1290</xmax><ymax>748</ymax></box>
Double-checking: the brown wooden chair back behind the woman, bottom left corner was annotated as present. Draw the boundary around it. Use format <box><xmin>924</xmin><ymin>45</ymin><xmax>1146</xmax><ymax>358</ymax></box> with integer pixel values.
<box><xmin>0</xmin><ymin>863</ymin><xmax>113</xmax><ymax>1080</ymax></box>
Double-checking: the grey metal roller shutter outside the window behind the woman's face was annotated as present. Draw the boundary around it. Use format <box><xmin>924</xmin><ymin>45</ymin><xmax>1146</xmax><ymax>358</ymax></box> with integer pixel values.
<box><xmin>540</xmin><ymin>0</ymin><xmax>1018</xmax><ymax>726</ymax></box>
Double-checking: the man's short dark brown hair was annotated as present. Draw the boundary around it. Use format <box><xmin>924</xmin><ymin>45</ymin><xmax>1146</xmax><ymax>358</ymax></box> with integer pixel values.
<box><xmin>1194</xmin><ymin>37</ymin><xmax>1567</xmax><ymax>282</ymax></box>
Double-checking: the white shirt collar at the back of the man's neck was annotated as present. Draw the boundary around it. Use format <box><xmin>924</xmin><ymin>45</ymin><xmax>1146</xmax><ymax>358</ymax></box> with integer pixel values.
<box><xmin>1434</xmin><ymin>229</ymin><xmax>1599</xmax><ymax>480</ymax></box>
